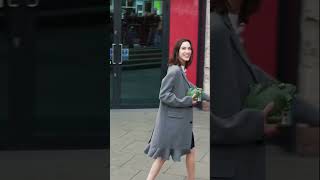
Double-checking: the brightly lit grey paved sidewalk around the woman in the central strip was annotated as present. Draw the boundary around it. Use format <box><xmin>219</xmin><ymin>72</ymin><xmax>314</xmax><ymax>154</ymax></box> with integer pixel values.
<box><xmin>110</xmin><ymin>109</ymin><xmax>210</xmax><ymax>180</ymax></box>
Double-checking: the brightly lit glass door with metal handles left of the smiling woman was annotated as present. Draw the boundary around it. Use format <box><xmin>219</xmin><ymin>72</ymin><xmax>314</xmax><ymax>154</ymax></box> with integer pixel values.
<box><xmin>110</xmin><ymin>0</ymin><xmax>166</xmax><ymax>108</ymax></box>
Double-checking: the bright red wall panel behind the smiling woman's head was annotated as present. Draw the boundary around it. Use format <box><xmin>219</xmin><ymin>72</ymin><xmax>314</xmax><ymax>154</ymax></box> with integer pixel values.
<box><xmin>169</xmin><ymin>0</ymin><xmax>199</xmax><ymax>84</ymax></box>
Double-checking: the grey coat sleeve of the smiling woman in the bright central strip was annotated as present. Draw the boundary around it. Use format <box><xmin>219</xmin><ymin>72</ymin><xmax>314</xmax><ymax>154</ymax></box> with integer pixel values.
<box><xmin>159</xmin><ymin>67</ymin><xmax>192</xmax><ymax>107</ymax></box>
